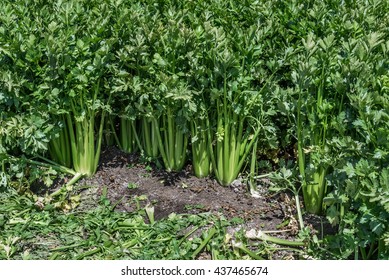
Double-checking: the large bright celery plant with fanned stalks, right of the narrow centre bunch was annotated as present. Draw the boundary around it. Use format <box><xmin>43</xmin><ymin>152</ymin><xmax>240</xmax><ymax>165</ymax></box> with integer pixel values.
<box><xmin>206</xmin><ymin>20</ymin><xmax>282</xmax><ymax>185</ymax></box>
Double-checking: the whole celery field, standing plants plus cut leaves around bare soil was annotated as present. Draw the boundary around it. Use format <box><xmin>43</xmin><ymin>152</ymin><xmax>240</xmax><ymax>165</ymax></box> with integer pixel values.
<box><xmin>0</xmin><ymin>0</ymin><xmax>389</xmax><ymax>259</ymax></box>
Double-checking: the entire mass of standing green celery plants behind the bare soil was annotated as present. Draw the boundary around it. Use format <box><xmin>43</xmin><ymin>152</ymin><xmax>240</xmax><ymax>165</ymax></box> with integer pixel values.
<box><xmin>0</xmin><ymin>0</ymin><xmax>389</xmax><ymax>258</ymax></box>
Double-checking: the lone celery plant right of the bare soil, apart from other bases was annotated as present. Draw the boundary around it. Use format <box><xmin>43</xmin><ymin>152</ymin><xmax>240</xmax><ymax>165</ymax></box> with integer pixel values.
<box><xmin>294</xmin><ymin>34</ymin><xmax>343</xmax><ymax>214</ymax></box>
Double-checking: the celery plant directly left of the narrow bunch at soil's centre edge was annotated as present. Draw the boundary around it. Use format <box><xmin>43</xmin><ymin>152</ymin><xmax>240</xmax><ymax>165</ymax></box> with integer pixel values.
<box><xmin>142</xmin><ymin>7</ymin><xmax>194</xmax><ymax>171</ymax></box>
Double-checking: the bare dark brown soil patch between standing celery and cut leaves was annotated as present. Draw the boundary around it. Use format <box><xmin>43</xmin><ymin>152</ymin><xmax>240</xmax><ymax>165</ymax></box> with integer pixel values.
<box><xmin>72</xmin><ymin>147</ymin><xmax>329</xmax><ymax>242</ymax></box>
